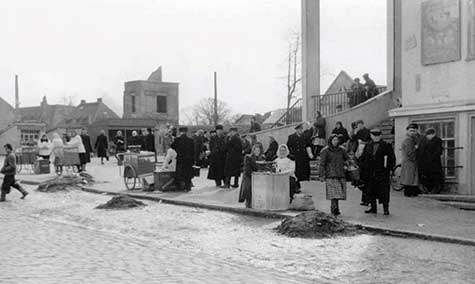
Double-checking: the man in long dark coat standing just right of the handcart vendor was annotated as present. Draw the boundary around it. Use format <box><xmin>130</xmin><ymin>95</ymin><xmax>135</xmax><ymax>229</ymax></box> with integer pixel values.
<box><xmin>171</xmin><ymin>127</ymin><xmax>195</xmax><ymax>191</ymax></box>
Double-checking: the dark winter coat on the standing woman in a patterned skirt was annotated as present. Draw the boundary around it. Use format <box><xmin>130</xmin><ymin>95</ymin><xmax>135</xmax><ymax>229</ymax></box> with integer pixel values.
<box><xmin>319</xmin><ymin>144</ymin><xmax>349</xmax><ymax>179</ymax></box>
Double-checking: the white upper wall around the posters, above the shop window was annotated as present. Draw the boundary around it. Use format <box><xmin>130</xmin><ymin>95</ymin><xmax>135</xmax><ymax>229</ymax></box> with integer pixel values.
<box><xmin>401</xmin><ymin>0</ymin><xmax>475</xmax><ymax>107</ymax></box>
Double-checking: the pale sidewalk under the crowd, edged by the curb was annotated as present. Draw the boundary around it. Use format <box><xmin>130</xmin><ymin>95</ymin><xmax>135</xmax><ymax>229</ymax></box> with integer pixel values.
<box><xmin>6</xmin><ymin>159</ymin><xmax>475</xmax><ymax>245</ymax></box>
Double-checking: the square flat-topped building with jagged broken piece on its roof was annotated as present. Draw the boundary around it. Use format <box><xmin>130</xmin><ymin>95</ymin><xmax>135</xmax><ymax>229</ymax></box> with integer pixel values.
<box><xmin>123</xmin><ymin>67</ymin><xmax>179</xmax><ymax>125</ymax></box>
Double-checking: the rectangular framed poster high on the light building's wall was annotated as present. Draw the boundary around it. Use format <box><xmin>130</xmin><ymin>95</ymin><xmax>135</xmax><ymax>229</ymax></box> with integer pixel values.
<box><xmin>421</xmin><ymin>0</ymin><xmax>461</xmax><ymax>65</ymax></box>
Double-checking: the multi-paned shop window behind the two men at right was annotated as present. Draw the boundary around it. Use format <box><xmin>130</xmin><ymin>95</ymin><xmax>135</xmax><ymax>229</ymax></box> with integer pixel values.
<box><xmin>416</xmin><ymin>119</ymin><xmax>456</xmax><ymax>180</ymax></box>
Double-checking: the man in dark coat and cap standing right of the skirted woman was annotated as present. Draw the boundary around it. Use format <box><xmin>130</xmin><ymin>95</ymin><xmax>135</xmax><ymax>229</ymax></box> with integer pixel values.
<box><xmin>360</xmin><ymin>128</ymin><xmax>396</xmax><ymax>215</ymax></box>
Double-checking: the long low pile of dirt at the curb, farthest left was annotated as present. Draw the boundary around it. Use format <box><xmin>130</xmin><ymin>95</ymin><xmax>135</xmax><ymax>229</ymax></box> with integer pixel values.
<box><xmin>36</xmin><ymin>173</ymin><xmax>95</xmax><ymax>192</ymax></box>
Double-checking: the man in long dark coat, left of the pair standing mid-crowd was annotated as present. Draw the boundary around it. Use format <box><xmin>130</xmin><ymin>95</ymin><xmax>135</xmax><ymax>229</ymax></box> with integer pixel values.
<box><xmin>208</xmin><ymin>125</ymin><xmax>226</xmax><ymax>186</ymax></box>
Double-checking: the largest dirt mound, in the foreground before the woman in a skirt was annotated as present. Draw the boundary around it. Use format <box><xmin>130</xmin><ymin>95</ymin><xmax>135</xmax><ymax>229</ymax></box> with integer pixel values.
<box><xmin>276</xmin><ymin>211</ymin><xmax>362</xmax><ymax>239</ymax></box>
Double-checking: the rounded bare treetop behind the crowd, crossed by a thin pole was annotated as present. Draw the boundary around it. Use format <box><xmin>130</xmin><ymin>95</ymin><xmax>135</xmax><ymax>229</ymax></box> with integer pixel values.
<box><xmin>191</xmin><ymin>98</ymin><xmax>231</xmax><ymax>125</ymax></box>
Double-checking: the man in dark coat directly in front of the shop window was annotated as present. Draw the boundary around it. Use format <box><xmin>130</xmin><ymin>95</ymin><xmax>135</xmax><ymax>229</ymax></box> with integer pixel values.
<box><xmin>417</xmin><ymin>128</ymin><xmax>444</xmax><ymax>194</ymax></box>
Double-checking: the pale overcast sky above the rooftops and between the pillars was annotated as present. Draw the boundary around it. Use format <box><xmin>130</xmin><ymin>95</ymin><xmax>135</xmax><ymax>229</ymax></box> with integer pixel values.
<box><xmin>0</xmin><ymin>0</ymin><xmax>386</xmax><ymax>121</ymax></box>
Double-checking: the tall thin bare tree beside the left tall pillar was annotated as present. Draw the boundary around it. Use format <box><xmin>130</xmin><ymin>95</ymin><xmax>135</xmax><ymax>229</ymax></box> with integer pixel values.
<box><xmin>286</xmin><ymin>33</ymin><xmax>302</xmax><ymax>124</ymax></box>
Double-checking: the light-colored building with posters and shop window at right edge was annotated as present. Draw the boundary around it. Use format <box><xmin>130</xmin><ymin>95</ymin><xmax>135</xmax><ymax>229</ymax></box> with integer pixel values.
<box><xmin>388</xmin><ymin>0</ymin><xmax>475</xmax><ymax>195</ymax></box>
